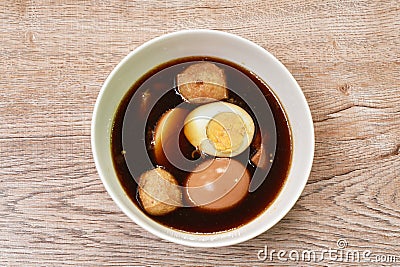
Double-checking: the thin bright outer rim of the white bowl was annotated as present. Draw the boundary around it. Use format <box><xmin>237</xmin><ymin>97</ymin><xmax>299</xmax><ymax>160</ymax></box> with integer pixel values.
<box><xmin>91</xmin><ymin>29</ymin><xmax>315</xmax><ymax>247</ymax></box>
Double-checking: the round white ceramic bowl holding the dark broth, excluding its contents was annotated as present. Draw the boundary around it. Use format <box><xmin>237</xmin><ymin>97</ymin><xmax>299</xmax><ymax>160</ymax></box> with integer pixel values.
<box><xmin>91</xmin><ymin>30</ymin><xmax>314</xmax><ymax>247</ymax></box>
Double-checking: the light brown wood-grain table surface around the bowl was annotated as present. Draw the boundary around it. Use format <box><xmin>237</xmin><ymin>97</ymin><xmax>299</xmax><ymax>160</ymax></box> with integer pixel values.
<box><xmin>0</xmin><ymin>0</ymin><xmax>400</xmax><ymax>266</ymax></box>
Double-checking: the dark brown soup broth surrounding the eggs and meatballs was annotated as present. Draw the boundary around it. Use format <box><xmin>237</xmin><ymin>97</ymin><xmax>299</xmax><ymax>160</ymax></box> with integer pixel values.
<box><xmin>111</xmin><ymin>57</ymin><xmax>292</xmax><ymax>233</ymax></box>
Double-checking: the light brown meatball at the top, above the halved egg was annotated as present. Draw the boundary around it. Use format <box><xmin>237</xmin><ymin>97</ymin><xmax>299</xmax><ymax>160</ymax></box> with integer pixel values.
<box><xmin>176</xmin><ymin>61</ymin><xmax>228</xmax><ymax>104</ymax></box>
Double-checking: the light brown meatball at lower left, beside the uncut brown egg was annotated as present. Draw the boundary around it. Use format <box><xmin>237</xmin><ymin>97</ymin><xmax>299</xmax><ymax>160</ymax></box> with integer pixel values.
<box><xmin>139</xmin><ymin>167</ymin><xmax>183</xmax><ymax>216</ymax></box>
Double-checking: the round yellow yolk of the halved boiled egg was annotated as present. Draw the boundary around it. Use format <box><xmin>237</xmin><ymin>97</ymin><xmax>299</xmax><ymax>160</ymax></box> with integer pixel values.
<box><xmin>206</xmin><ymin>112</ymin><xmax>246</xmax><ymax>153</ymax></box>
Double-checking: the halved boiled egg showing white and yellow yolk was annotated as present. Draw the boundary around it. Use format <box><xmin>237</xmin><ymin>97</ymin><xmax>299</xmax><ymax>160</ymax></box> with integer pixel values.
<box><xmin>184</xmin><ymin>101</ymin><xmax>254</xmax><ymax>157</ymax></box>
